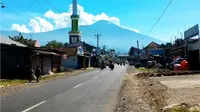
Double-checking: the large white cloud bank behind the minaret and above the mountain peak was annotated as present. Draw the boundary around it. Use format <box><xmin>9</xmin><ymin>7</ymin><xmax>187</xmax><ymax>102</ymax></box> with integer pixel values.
<box><xmin>10</xmin><ymin>4</ymin><xmax>139</xmax><ymax>33</ymax></box>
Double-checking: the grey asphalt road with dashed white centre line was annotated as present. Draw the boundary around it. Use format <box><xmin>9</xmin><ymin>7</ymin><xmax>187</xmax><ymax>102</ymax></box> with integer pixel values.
<box><xmin>0</xmin><ymin>65</ymin><xmax>127</xmax><ymax>112</ymax></box>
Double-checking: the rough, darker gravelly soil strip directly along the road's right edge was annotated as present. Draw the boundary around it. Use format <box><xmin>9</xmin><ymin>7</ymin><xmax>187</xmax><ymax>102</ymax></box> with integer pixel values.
<box><xmin>115</xmin><ymin>69</ymin><xmax>167</xmax><ymax>112</ymax></box>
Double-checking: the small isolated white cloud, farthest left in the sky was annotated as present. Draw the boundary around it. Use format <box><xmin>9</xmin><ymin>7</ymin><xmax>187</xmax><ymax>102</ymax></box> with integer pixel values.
<box><xmin>11</xmin><ymin>24</ymin><xmax>30</xmax><ymax>33</ymax></box>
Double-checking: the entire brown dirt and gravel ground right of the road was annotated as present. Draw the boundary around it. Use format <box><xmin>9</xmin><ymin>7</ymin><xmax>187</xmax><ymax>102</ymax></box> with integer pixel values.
<box><xmin>115</xmin><ymin>67</ymin><xmax>200</xmax><ymax>112</ymax></box>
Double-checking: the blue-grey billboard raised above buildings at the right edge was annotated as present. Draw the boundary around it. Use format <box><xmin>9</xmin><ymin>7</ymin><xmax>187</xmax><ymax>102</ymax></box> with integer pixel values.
<box><xmin>184</xmin><ymin>24</ymin><xmax>199</xmax><ymax>40</ymax></box>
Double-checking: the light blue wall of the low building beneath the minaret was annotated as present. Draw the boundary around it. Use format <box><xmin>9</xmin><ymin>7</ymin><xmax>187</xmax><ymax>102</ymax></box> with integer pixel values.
<box><xmin>61</xmin><ymin>56</ymin><xmax>78</xmax><ymax>68</ymax></box>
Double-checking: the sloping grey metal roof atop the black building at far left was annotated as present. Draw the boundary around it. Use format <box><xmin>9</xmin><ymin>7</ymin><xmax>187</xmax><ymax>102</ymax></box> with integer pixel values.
<box><xmin>0</xmin><ymin>36</ymin><xmax>27</xmax><ymax>47</ymax></box>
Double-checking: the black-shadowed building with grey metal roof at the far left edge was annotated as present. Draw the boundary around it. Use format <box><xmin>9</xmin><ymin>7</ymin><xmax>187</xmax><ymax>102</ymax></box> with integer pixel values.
<box><xmin>0</xmin><ymin>37</ymin><xmax>31</xmax><ymax>79</ymax></box>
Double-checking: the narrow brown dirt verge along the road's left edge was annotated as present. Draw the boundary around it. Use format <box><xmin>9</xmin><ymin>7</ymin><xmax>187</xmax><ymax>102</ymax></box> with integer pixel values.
<box><xmin>0</xmin><ymin>68</ymin><xmax>96</xmax><ymax>96</ymax></box>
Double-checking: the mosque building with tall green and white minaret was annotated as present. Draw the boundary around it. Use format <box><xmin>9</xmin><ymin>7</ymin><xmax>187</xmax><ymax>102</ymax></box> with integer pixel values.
<box><xmin>62</xmin><ymin>0</ymin><xmax>96</xmax><ymax>69</ymax></box>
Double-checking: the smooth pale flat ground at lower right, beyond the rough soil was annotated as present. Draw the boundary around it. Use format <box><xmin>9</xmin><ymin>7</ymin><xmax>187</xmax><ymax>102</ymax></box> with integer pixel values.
<box><xmin>151</xmin><ymin>75</ymin><xmax>200</xmax><ymax>111</ymax></box>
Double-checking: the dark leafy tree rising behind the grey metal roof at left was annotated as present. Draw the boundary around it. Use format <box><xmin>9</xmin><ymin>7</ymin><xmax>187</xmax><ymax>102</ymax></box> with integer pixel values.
<box><xmin>8</xmin><ymin>33</ymin><xmax>35</xmax><ymax>47</ymax></box>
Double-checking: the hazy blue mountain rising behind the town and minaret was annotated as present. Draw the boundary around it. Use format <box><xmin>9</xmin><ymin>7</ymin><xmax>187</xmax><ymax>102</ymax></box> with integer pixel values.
<box><xmin>1</xmin><ymin>21</ymin><xmax>165</xmax><ymax>52</ymax></box>
